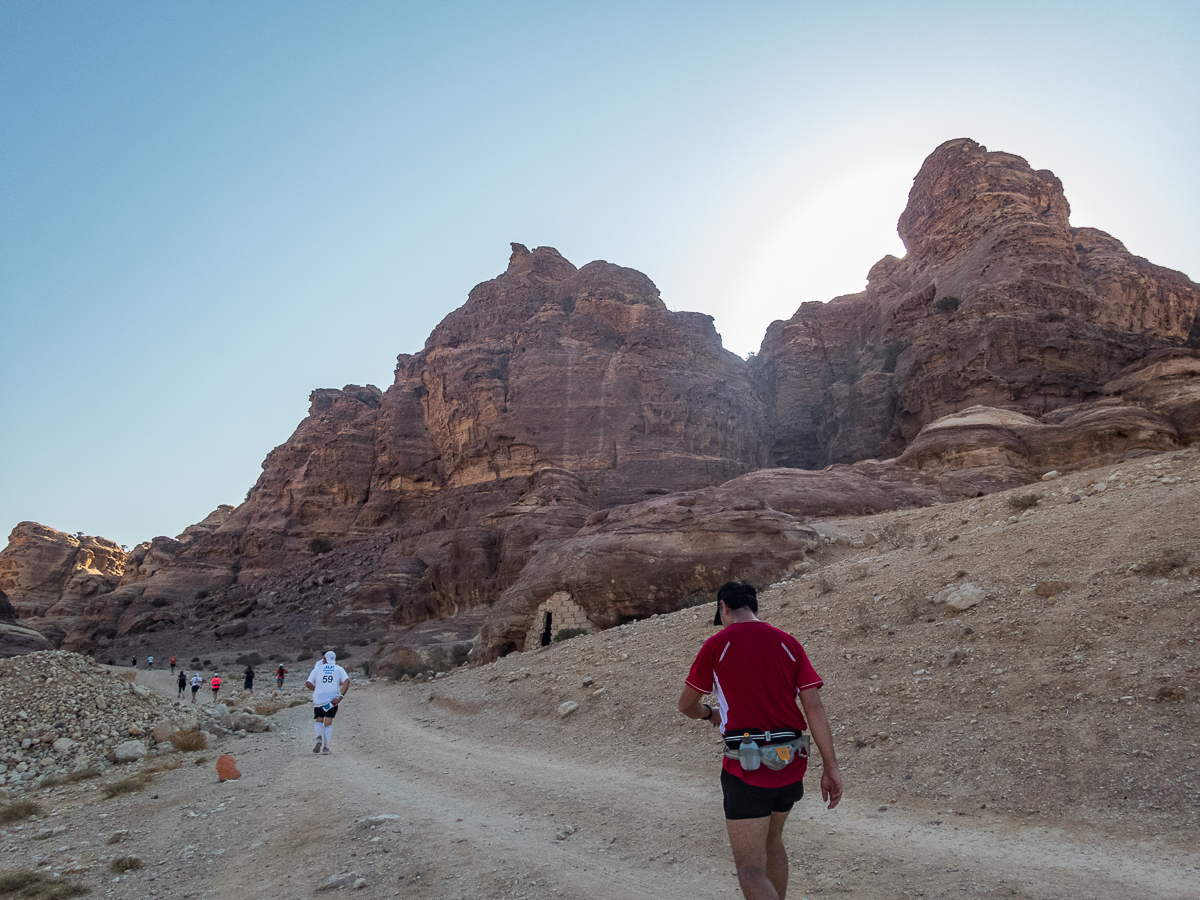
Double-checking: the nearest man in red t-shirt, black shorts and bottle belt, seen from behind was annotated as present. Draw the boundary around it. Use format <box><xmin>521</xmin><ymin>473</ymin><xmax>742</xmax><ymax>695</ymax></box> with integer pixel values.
<box><xmin>679</xmin><ymin>581</ymin><xmax>841</xmax><ymax>900</ymax></box>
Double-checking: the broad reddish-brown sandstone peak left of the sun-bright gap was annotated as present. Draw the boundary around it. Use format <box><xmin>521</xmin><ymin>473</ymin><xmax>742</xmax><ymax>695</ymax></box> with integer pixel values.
<box><xmin>174</xmin><ymin>245</ymin><xmax>766</xmax><ymax>626</ymax></box>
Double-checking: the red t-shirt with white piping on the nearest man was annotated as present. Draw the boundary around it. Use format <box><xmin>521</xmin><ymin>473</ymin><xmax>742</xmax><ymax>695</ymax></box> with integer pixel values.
<box><xmin>688</xmin><ymin>622</ymin><xmax>824</xmax><ymax>787</ymax></box>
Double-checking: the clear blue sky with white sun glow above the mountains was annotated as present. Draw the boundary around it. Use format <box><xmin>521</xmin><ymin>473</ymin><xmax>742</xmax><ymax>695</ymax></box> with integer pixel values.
<box><xmin>7</xmin><ymin>0</ymin><xmax>1200</xmax><ymax>546</ymax></box>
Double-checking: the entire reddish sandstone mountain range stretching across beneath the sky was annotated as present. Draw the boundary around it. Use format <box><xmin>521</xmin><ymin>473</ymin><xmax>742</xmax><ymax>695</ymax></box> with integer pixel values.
<box><xmin>0</xmin><ymin>139</ymin><xmax>1200</xmax><ymax>668</ymax></box>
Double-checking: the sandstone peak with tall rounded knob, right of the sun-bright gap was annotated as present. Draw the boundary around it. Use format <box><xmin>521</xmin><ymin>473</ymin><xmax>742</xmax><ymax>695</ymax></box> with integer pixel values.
<box><xmin>755</xmin><ymin>139</ymin><xmax>1200</xmax><ymax>468</ymax></box>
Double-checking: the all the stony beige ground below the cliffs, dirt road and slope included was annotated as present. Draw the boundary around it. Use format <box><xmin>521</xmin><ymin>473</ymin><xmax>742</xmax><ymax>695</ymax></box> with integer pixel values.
<box><xmin>0</xmin><ymin>451</ymin><xmax>1200</xmax><ymax>900</ymax></box>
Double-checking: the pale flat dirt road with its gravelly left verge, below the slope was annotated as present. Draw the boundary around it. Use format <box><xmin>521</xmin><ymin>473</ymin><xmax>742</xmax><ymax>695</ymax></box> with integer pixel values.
<box><xmin>16</xmin><ymin>672</ymin><xmax>1200</xmax><ymax>900</ymax></box>
